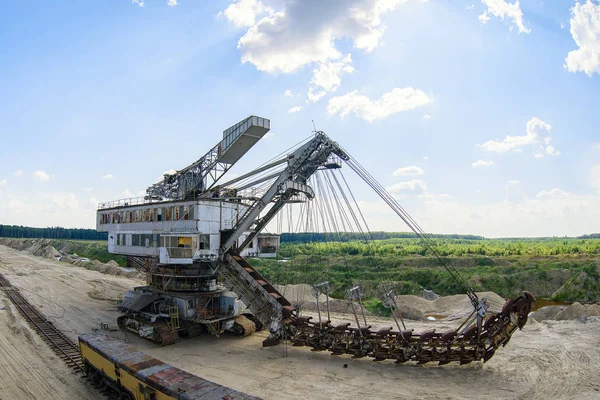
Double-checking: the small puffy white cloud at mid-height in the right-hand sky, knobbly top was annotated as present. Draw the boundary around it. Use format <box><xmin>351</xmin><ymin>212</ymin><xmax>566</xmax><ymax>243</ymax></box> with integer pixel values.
<box><xmin>480</xmin><ymin>117</ymin><xmax>560</xmax><ymax>158</ymax></box>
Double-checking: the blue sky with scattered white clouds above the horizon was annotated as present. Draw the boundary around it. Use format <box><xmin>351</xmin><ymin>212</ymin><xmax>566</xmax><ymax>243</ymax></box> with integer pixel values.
<box><xmin>0</xmin><ymin>0</ymin><xmax>600</xmax><ymax>237</ymax></box>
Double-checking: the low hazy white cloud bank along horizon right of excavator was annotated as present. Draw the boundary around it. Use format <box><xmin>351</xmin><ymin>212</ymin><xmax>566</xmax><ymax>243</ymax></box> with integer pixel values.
<box><xmin>361</xmin><ymin>191</ymin><xmax>600</xmax><ymax>237</ymax></box>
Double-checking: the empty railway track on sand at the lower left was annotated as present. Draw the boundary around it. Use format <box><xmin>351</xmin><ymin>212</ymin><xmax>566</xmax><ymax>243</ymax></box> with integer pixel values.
<box><xmin>0</xmin><ymin>274</ymin><xmax>84</xmax><ymax>372</ymax></box>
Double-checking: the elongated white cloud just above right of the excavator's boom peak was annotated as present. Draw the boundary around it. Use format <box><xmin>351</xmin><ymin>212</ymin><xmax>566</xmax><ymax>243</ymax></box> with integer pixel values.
<box><xmin>327</xmin><ymin>87</ymin><xmax>433</xmax><ymax>122</ymax></box>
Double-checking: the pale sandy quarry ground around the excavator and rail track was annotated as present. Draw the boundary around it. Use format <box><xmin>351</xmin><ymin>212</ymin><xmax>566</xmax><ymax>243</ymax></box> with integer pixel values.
<box><xmin>0</xmin><ymin>246</ymin><xmax>600</xmax><ymax>400</ymax></box>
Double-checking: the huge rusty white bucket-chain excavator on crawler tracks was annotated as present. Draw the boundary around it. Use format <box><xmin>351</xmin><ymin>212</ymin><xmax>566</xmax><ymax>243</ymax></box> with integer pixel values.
<box><xmin>97</xmin><ymin>116</ymin><xmax>535</xmax><ymax>365</ymax></box>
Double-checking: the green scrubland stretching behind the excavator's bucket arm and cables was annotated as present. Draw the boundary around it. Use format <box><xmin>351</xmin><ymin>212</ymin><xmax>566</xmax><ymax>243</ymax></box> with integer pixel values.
<box><xmin>246</xmin><ymin>237</ymin><xmax>600</xmax><ymax>302</ymax></box>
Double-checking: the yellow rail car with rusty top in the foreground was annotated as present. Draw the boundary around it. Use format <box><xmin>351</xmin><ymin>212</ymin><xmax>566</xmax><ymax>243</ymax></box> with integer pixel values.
<box><xmin>79</xmin><ymin>333</ymin><xmax>259</xmax><ymax>400</ymax></box>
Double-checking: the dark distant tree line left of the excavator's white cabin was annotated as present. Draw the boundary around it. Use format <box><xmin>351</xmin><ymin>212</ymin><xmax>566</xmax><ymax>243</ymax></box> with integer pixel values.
<box><xmin>0</xmin><ymin>224</ymin><xmax>108</xmax><ymax>240</ymax></box>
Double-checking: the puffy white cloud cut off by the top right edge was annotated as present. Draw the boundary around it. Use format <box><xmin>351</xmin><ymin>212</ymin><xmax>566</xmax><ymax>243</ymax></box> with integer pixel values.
<box><xmin>565</xmin><ymin>0</ymin><xmax>600</xmax><ymax>76</ymax></box>
